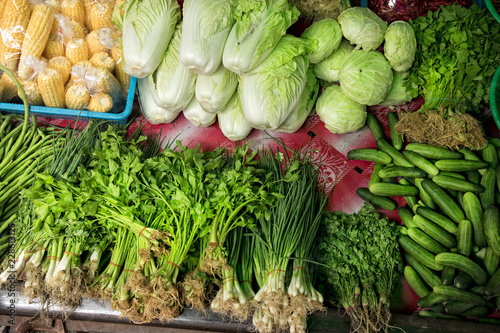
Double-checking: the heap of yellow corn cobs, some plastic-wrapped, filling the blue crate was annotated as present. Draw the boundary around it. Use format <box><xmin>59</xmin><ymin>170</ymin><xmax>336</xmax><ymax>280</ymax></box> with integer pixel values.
<box><xmin>0</xmin><ymin>0</ymin><xmax>130</xmax><ymax>112</ymax></box>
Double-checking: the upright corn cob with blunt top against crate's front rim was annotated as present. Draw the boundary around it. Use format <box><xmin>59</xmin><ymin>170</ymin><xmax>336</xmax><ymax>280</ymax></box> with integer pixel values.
<box><xmin>37</xmin><ymin>68</ymin><xmax>66</xmax><ymax>108</ymax></box>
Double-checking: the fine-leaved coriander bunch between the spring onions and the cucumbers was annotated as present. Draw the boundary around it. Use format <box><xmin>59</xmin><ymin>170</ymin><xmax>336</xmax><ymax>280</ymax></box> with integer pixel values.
<box><xmin>320</xmin><ymin>204</ymin><xmax>401</xmax><ymax>332</ymax></box>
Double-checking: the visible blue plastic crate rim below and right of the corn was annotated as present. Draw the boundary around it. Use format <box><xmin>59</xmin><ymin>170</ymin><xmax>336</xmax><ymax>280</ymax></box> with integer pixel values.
<box><xmin>0</xmin><ymin>77</ymin><xmax>137</xmax><ymax>125</ymax></box>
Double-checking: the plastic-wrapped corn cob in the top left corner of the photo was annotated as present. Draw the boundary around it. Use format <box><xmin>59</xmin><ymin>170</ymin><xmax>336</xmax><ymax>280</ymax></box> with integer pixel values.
<box><xmin>0</xmin><ymin>0</ymin><xmax>31</xmax><ymax>72</ymax></box>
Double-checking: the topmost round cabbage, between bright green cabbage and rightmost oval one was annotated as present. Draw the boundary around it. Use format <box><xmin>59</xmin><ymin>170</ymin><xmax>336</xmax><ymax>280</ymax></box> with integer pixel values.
<box><xmin>338</xmin><ymin>7</ymin><xmax>387</xmax><ymax>51</ymax></box>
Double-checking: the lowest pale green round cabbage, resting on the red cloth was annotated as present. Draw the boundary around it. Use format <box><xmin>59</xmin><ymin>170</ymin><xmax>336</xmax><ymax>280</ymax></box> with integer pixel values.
<box><xmin>316</xmin><ymin>85</ymin><xmax>366</xmax><ymax>134</ymax></box>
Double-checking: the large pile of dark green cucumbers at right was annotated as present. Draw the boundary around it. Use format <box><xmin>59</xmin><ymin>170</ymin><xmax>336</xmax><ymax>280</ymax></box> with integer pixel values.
<box><xmin>348</xmin><ymin>113</ymin><xmax>500</xmax><ymax>322</ymax></box>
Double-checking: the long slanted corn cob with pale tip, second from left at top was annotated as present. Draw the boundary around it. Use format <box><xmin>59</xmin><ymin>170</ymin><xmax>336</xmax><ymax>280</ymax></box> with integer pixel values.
<box><xmin>18</xmin><ymin>3</ymin><xmax>54</xmax><ymax>80</ymax></box>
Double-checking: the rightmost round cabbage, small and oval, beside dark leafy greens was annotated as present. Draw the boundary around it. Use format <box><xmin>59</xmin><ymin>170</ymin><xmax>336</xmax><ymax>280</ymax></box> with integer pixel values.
<box><xmin>384</xmin><ymin>21</ymin><xmax>417</xmax><ymax>72</ymax></box>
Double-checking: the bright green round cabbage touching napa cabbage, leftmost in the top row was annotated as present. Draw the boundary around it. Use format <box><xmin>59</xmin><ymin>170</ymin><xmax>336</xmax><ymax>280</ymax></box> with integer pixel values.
<box><xmin>300</xmin><ymin>18</ymin><xmax>342</xmax><ymax>64</ymax></box>
